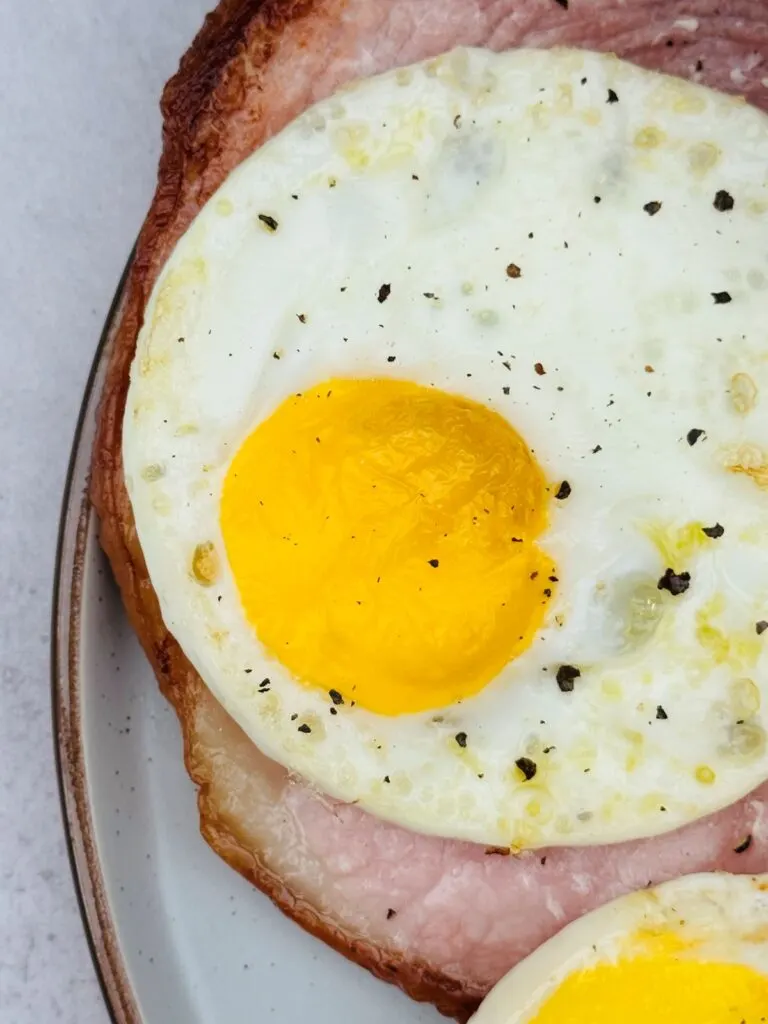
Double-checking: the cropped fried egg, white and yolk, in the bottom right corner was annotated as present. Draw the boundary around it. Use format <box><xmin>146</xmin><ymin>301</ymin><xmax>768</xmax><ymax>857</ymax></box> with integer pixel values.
<box><xmin>472</xmin><ymin>873</ymin><xmax>768</xmax><ymax>1024</ymax></box>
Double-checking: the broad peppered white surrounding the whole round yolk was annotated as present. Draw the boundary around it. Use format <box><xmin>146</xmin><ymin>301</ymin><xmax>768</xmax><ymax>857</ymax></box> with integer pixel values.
<box><xmin>123</xmin><ymin>50</ymin><xmax>768</xmax><ymax>847</ymax></box>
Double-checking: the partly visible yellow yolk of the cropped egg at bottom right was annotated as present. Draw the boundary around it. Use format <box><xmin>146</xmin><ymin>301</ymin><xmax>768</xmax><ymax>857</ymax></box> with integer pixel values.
<box><xmin>529</xmin><ymin>956</ymin><xmax>768</xmax><ymax>1024</ymax></box>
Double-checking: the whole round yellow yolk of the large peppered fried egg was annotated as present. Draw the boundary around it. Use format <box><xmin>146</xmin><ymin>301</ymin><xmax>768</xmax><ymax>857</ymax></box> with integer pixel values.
<box><xmin>220</xmin><ymin>379</ymin><xmax>557</xmax><ymax>715</ymax></box>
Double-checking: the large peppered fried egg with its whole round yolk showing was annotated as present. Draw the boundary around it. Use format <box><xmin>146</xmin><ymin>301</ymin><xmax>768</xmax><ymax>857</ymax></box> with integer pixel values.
<box><xmin>123</xmin><ymin>50</ymin><xmax>768</xmax><ymax>849</ymax></box>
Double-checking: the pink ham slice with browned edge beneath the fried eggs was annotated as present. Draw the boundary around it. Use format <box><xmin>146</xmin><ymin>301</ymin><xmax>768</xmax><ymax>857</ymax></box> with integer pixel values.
<box><xmin>91</xmin><ymin>0</ymin><xmax>768</xmax><ymax>1020</ymax></box>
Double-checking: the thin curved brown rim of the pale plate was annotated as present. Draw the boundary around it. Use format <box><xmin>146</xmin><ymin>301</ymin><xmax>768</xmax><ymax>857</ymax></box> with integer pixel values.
<box><xmin>50</xmin><ymin>253</ymin><xmax>142</xmax><ymax>1024</ymax></box>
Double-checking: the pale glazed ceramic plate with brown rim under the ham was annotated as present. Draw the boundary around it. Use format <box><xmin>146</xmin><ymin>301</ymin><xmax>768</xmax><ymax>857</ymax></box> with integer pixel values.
<box><xmin>53</xmin><ymin>264</ymin><xmax>443</xmax><ymax>1024</ymax></box>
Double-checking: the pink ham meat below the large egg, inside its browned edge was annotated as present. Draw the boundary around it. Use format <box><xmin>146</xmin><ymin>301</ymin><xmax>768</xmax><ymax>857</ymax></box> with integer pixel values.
<box><xmin>198</xmin><ymin>701</ymin><xmax>768</xmax><ymax>1005</ymax></box>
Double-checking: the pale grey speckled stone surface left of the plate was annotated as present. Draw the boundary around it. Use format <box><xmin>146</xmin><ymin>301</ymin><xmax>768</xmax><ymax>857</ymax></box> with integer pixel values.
<box><xmin>0</xmin><ymin>0</ymin><xmax>212</xmax><ymax>1024</ymax></box>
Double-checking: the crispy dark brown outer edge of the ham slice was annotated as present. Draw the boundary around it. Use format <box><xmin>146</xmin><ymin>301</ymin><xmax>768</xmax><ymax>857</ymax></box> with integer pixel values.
<box><xmin>90</xmin><ymin>0</ymin><xmax>477</xmax><ymax>1021</ymax></box>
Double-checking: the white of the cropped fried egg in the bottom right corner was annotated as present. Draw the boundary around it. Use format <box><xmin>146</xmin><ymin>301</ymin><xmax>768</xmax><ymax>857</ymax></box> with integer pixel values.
<box><xmin>471</xmin><ymin>871</ymin><xmax>768</xmax><ymax>1024</ymax></box>
